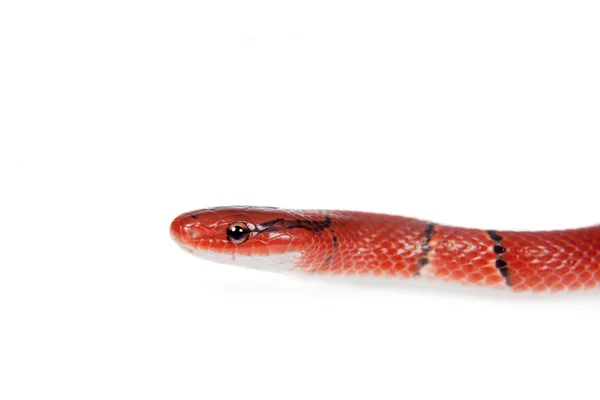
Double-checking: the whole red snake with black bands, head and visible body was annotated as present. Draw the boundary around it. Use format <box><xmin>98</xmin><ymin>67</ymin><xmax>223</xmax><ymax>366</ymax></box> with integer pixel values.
<box><xmin>171</xmin><ymin>207</ymin><xmax>600</xmax><ymax>292</ymax></box>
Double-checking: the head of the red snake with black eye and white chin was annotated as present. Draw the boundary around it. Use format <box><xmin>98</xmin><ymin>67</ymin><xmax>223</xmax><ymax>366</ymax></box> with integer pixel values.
<box><xmin>171</xmin><ymin>207</ymin><xmax>331</xmax><ymax>270</ymax></box>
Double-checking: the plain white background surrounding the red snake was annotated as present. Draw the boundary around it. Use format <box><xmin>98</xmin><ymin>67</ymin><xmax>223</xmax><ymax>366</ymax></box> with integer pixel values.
<box><xmin>0</xmin><ymin>0</ymin><xmax>600</xmax><ymax>399</ymax></box>
